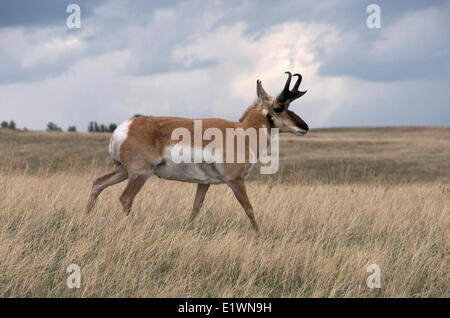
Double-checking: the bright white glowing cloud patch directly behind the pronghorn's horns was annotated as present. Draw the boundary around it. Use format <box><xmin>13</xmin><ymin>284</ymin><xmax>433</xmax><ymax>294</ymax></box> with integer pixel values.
<box><xmin>174</xmin><ymin>23</ymin><xmax>337</xmax><ymax>123</ymax></box>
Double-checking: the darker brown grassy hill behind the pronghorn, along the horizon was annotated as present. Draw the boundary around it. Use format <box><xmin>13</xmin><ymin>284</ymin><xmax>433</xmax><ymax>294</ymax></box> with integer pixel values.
<box><xmin>0</xmin><ymin>127</ymin><xmax>450</xmax><ymax>183</ymax></box>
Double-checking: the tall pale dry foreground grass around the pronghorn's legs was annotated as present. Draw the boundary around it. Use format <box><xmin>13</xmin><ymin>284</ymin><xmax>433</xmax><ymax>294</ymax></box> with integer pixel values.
<box><xmin>0</xmin><ymin>171</ymin><xmax>450</xmax><ymax>297</ymax></box>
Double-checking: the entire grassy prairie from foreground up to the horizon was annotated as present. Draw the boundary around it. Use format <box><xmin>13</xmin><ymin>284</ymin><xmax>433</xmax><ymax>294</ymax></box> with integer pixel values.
<box><xmin>0</xmin><ymin>127</ymin><xmax>450</xmax><ymax>297</ymax></box>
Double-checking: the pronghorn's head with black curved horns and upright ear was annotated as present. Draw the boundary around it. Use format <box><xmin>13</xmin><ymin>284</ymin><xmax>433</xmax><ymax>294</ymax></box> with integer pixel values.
<box><xmin>256</xmin><ymin>72</ymin><xmax>309</xmax><ymax>136</ymax></box>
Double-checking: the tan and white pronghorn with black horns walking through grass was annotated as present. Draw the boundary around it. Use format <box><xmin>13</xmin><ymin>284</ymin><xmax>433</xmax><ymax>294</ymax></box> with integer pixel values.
<box><xmin>86</xmin><ymin>72</ymin><xmax>308</xmax><ymax>232</ymax></box>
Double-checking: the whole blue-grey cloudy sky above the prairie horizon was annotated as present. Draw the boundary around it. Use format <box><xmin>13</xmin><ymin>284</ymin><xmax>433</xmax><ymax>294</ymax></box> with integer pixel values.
<box><xmin>0</xmin><ymin>0</ymin><xmax>450</xmax><ymax>130</ymax></box>
